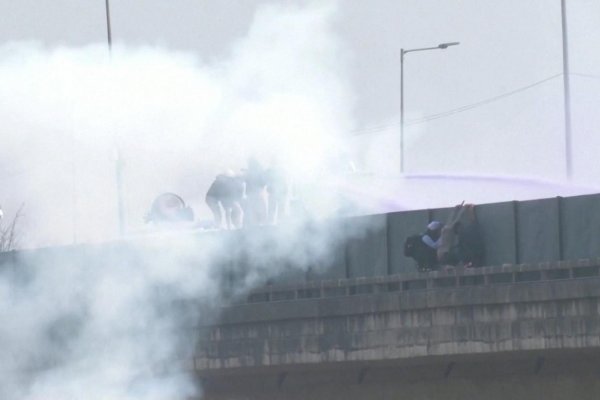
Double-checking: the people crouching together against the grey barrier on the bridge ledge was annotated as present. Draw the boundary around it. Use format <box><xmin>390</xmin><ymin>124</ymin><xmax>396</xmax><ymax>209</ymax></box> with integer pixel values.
<box><xmin>404</xmin><ymin>203</ymin><xmax>484</xmax><ymax>271</ymax></box>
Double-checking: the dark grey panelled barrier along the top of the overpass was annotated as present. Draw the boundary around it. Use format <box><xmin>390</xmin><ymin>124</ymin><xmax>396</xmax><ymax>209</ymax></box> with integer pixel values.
<box><xmin>258</xmin><ymin>194</ymin><xmax>600</xmax><ymax>285</ymax></box>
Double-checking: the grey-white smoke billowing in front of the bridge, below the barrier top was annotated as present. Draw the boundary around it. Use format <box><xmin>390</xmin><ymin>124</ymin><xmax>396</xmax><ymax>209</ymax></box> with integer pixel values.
<box><xmin>0</xmin><ymin>221</ymin><xmax>360</xmax><ymax>400</ymax></box>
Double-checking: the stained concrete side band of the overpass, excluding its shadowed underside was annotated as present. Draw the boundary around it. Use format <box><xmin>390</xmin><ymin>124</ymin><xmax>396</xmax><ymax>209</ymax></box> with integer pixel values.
<box><xmin>195</xmin><ymin>266</ymin><xmax>600</xmax><ymax>371</ymax></box>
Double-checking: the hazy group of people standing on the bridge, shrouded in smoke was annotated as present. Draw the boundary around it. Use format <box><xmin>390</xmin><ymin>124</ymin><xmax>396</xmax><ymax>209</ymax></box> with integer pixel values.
<box><xmin>205</xmin><ymin>158</ymin><xmax>289</xmax><ymax>229</ymax></box>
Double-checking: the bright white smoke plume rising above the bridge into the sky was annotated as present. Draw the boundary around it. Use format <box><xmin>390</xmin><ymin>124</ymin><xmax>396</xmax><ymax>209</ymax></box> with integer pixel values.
<box><xmin>0</xmin><ymin>3</ymin><xmax>352</xmax><ymax>246</ymax></box>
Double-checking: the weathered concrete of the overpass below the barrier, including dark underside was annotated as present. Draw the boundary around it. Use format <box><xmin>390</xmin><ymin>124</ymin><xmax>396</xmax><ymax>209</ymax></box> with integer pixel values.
<box><xmin>194</xmin><ymin>263</ymin><xmax>600</xmax><ymax>399</ymax></box>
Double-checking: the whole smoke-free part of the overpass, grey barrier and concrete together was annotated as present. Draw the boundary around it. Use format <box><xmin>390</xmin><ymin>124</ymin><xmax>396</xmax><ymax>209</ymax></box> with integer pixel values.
<box><xmin>193</xmin><ymin>196</ymin><xmax>600</xmax><ymax>399</ymax></box>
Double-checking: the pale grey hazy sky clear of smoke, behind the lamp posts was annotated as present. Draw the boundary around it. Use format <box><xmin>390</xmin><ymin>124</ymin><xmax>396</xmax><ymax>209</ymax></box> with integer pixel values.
<box><xmin>0</xmin><ymin>0</ymin><xmax>600</xmax><ymax>170</ymax></box>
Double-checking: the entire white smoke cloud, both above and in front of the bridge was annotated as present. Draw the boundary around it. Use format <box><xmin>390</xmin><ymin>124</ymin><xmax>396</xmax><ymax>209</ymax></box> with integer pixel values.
<box><xmin>0</xmin><ymin>4</ymin><xmax>370</xmax><ymax>400</ymax></box>
